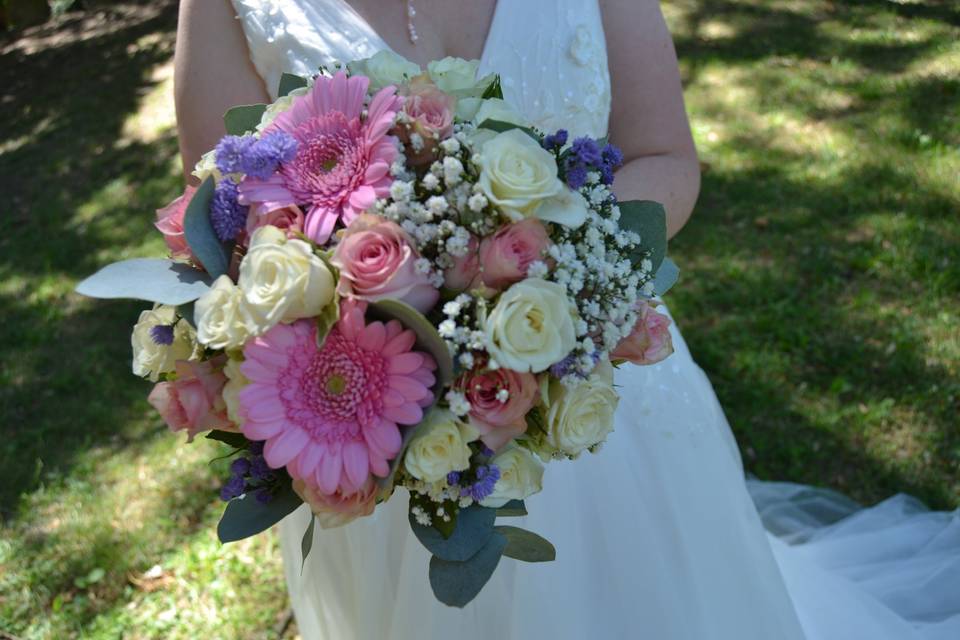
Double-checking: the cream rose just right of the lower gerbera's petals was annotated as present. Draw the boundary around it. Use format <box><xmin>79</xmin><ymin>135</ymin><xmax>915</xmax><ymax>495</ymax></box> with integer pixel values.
<box><xmin>403</xmin><ymin>408</ymin><xmax>479</xmax><ymax>482</ymax></box>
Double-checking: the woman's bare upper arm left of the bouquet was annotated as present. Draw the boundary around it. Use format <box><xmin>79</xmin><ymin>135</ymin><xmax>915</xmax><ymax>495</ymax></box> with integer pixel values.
<box><xmin>173</xmin><ymin>0</ymin><xmax>269</xmax><ymax>182</ymax></box>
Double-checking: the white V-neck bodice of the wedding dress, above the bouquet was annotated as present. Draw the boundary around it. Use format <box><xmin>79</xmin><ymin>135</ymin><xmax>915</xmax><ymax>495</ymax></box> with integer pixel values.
<box><xmin>233</xmin><ymin>0</ymin><xmax>610</xmax><ymax>137</ymax></box>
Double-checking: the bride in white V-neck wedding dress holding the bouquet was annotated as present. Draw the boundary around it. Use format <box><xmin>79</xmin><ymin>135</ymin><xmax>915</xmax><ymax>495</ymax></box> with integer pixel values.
<box><xmin>176</xmin><ymin>0</ymin><xmax>960</xmax><ymax>640</ymax></box>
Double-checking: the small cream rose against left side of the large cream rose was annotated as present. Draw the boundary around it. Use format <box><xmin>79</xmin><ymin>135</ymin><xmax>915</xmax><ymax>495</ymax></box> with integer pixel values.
<box><xmin>193</xmin><ymin>275</ymin><xmax>256</xmax><ymax>349</ymax></box>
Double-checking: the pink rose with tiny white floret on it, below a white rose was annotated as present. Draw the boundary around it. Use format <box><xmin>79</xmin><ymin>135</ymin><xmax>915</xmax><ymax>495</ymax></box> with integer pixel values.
<box><xmin>458</xmin><ymin>368</ymin><xmax>540</xmax><ymax>451</ymax></box>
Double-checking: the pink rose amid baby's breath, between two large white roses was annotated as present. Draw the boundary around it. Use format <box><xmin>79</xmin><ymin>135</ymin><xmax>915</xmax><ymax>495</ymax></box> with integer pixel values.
<box><xmin>480</xmin><ymin>218</ymin><xmax>550</xmax><ymax>289</ymax></box>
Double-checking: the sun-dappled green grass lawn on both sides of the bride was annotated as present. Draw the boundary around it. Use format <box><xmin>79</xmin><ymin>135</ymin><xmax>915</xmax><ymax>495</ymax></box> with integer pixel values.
<box><xmin>0</xmin><ymin>0</ymin><xmax>960</xmax><ymax>640</ymax></box>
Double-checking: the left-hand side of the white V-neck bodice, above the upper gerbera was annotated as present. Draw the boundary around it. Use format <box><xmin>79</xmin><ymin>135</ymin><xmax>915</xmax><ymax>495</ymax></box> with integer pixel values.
<box><xmin>232</xmin><ymin>0</ymin><xmax>389</xmax><ymax>99</ymax></box>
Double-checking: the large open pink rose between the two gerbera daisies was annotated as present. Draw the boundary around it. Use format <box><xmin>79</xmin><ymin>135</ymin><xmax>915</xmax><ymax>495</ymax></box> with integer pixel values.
<box><xmin>332</xmin><ymin>214</ymin><xmax>440</xmax><ymax>313</ymax></box>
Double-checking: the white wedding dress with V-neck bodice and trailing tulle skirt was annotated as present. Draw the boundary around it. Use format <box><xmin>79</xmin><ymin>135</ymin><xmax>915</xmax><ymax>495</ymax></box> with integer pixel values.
<box><xmin>233</xmin><ymin>0</ymin><xmax>960</xmax><ymax>640</ymax></box>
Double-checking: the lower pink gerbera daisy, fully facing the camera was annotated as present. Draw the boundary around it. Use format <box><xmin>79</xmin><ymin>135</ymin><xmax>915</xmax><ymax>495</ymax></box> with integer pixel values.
<box><xmin>240</xmin><ymin>303</ymin><xmax>436</xmax><ymax>495</ymax></box>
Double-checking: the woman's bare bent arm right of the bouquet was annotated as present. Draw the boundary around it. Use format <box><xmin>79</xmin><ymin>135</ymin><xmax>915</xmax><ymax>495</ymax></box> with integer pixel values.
<box><xmin>600</xmin><ymin>0</ymin><xmax>700</xmax><ymax>236</ymax></box>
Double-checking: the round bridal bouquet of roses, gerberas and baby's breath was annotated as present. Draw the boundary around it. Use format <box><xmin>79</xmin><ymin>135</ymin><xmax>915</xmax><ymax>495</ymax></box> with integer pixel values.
<box><xmin>78</xmin><ymin>53</ymin><xmax>677</xmax><ymax>606</ymax></box>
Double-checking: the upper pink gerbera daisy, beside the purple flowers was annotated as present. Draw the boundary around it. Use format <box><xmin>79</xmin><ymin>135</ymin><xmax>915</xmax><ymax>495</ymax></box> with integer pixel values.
<box><xmin>240</xmin><ymin>71</ymin><xmax>403</xmax><ymax>243</ymax></box>
